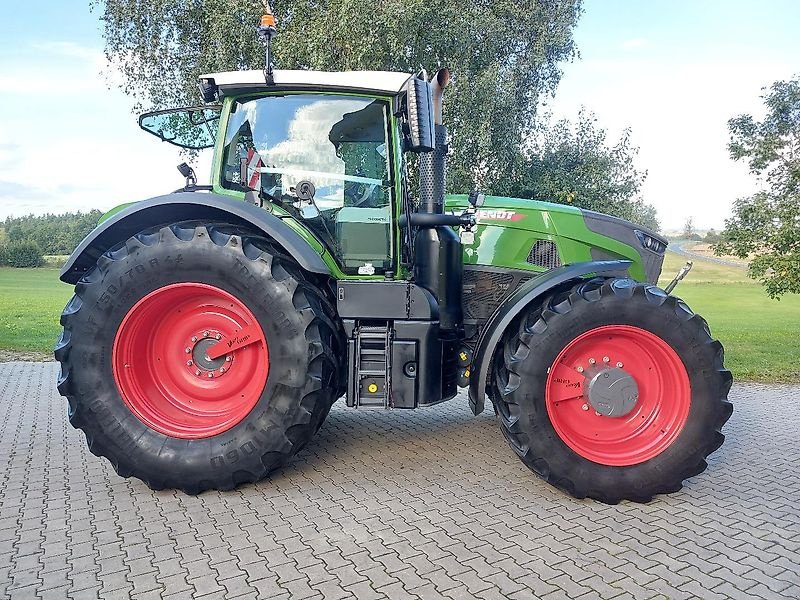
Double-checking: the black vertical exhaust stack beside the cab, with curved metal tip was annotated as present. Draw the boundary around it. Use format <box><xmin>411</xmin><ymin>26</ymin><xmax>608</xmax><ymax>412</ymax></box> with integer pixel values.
<box><xmin>414</xmin><ymin>69</ymin><xmax>464</xmax><ymax>340</ymax></box>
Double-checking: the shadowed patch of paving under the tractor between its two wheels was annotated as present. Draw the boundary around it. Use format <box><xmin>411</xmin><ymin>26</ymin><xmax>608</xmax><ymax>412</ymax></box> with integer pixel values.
<box><xmin>260</xmin><ymin>394</ymin><xmax>536</xmax><ymax>489</ymax></box>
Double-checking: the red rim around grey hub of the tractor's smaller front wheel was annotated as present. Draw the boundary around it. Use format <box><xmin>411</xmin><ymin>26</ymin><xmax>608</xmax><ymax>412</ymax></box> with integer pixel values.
<box><xmin>545</xmin><ymin>325</ymin><xmax>691</xmax><ymax>466</ymax></box>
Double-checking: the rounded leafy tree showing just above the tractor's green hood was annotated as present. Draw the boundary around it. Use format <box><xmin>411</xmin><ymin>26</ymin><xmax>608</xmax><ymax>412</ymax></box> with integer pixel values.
<box><xmin>500</xmin><ymin>109</ymin><xmax>659</xmax><ymax>230</ymax></box>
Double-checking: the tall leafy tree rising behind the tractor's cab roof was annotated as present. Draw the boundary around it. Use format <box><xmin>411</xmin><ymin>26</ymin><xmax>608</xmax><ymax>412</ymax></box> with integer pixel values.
<box><xmin>94</xmin><ymin>0</ymin><xmax>581</xmax><ymax>192</ymax></box>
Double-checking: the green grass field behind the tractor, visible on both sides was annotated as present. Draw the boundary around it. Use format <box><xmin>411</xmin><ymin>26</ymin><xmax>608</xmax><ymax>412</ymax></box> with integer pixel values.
<box><xmin>0</xmin><ymin>253</ymin><xmax>800</xmax><ymax>382</ymax></box>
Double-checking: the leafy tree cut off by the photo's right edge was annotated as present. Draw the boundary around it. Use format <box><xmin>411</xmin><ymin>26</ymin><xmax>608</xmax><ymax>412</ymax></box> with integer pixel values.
<box><xmin>715</xmin><ymin>76</ymin><xmax>800</xmax><ymax>298</ymax></box>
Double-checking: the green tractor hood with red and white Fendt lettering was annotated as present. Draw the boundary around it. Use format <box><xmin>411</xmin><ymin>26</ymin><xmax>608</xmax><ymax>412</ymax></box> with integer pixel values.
<box><xmin>446</xmin><ymin>195</ymin><xmax>667</xmax><ymax>283</ymax></box>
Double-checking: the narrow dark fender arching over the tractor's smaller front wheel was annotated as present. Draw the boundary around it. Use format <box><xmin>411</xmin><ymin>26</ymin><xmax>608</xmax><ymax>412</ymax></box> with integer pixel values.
<box><xmin>469</xmin><ymin>260</ymin><xmax>632</xmax><ymax>415</ymax></box>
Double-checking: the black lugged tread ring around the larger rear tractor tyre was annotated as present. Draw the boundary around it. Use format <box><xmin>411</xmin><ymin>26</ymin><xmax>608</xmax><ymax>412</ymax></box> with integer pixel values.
<box><xmin>55</xmin><ymin>222</ymin><xmax>344</xmax><ymax>494</ymax></box>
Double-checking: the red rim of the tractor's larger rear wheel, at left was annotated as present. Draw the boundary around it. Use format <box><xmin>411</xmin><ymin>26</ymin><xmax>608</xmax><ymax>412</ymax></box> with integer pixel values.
<box><xmin>112</xmin><ymin>283</ymin><xmax>269</xmax><ymax>439</ymax></box>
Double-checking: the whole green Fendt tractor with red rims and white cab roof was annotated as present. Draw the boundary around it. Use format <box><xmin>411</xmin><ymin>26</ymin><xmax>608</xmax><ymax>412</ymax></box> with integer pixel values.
<box><xmin>55</xmin><ymin>19</ymin><xmax>732</xmax><ymax>503</ymax></box>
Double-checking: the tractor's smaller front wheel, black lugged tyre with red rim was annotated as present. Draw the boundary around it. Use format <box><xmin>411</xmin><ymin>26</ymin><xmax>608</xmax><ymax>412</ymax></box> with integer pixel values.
<box><xmin>491</xmin><ymin>278</ymin><xmax>733</xmax><ymax>504</ymax></box>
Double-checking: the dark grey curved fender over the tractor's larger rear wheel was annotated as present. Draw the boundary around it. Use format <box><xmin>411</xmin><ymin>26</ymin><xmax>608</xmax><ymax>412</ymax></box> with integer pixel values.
<box><xmin>59</xmin><ymin>192</ymin><xmax>330</xmax><ymax>284</ymax></box>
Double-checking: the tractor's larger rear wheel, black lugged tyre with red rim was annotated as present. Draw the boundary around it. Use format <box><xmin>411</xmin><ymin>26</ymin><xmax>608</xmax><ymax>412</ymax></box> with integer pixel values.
<box><xmin>55</xmin><ymin>222</ymin><xmax>343</xmax><ymax>494</ymax></box>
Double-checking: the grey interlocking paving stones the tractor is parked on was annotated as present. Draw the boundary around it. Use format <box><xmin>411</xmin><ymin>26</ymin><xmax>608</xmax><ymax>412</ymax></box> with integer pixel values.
<box><xmin>0</xmin><ymin>362</ymin><xmax>800</xmax><ymax>600</ymax></box>
